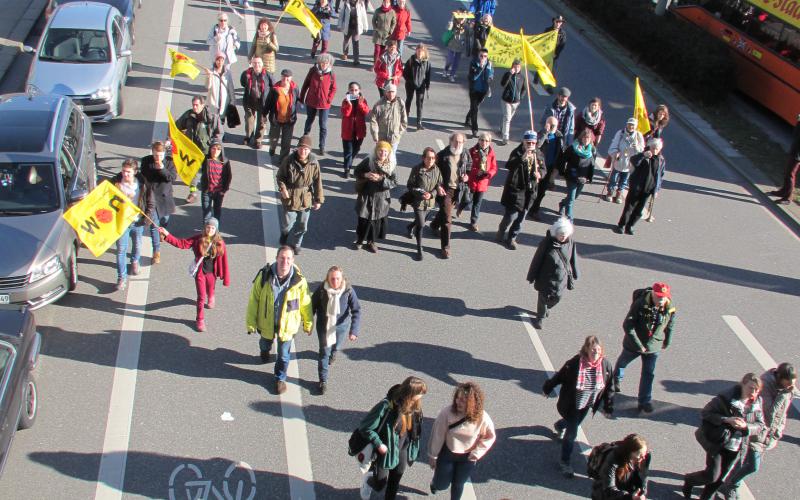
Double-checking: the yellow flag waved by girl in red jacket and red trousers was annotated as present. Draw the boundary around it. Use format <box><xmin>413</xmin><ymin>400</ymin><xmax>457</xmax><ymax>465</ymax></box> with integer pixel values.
<box><xmin>63</xmin><ymin>181</ymin><xmax>144</xmax><ymax>257</ymax></box>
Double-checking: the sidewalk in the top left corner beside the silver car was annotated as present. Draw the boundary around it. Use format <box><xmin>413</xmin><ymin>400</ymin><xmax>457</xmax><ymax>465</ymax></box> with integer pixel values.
<box><xmin>0</xmin><ymin>0</ymin><xmax>48</xmax><ymax>81</ymax></box>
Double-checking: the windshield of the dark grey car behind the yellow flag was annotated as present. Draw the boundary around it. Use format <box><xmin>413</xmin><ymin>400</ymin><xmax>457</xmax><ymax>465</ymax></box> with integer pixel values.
<box><xmin>0</xmin><ymin>163</ymin><xmax>59</xmax><ymax>216</ymax></box>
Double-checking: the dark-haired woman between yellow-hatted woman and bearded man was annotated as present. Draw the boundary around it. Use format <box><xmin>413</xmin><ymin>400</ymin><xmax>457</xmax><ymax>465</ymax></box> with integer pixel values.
<box><xmin>406</xmin><ymin>147</ymin><xmax>444</xmax><ymax>260</ymax></box>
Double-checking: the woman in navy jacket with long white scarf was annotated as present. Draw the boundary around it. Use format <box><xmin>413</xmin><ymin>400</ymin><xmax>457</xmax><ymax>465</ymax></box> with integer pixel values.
<box><xmin>311</xmin><ymin>266</ymin><xmax>361</xmax><ymax>395</ymax></box>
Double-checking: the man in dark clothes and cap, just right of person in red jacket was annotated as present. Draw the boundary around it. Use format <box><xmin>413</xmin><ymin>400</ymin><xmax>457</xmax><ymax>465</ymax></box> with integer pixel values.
<box><xmin>495</xmin><ymin>130</ymin><xmax>544</xmax><ymax>250</ymax></box>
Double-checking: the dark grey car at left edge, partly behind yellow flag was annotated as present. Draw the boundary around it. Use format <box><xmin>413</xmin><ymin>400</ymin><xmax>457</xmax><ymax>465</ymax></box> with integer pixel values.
<box><xmin>0</xmin><ymin>94</ymin><xmax>97</xmax><ymax>309</ymax></box>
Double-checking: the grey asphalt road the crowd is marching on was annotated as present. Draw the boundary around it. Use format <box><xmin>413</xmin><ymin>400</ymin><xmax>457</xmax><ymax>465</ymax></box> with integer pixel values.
<box><xmin>0</xmin><ymin>0</ymin><xmax>800</xmax><ymax>499</ymax></box>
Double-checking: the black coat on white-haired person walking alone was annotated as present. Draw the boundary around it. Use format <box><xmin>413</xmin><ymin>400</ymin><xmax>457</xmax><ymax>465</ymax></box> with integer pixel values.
<box><xmin>528</xmin><ymin>229</ymin><xmax>578</xmax><ymax>297</ymax></box>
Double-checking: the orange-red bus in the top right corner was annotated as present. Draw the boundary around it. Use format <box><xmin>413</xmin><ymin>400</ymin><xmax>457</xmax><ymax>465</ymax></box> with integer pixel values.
<box><xmin>670</xmin><ymin>0</ymin><xmax>800</xmax><ymax>125</ymax></box>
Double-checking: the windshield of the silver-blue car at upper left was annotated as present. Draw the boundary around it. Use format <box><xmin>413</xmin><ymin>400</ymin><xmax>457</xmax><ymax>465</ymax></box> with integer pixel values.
<box><xmin>39</xmin><ymin>28</ymin><xmax>111</xmax><ymax>64</ymax></box>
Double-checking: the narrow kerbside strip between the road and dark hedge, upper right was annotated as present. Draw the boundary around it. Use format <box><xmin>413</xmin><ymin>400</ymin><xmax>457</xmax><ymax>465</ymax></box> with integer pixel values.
<box><xmin>543</xmin><ymin>0</ymin><xmax>800</xmax><ymax>232</ymax></box>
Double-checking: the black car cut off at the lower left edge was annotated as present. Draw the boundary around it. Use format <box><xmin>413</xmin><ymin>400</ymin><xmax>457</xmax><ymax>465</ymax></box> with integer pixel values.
<box><xmin>0</xmin><ymin>308</ymin><xmax>42</xmax><ymax>472</ymax></box>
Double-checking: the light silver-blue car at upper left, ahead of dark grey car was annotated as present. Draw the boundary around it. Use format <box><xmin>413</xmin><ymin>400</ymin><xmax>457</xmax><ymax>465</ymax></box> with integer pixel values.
<box><xmin>24</xmin><ymin>2</ymin><xmax>132</xmax><ymax>121</ymax></box>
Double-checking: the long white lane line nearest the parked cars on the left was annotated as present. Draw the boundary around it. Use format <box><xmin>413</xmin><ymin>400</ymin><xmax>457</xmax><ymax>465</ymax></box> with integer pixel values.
<box><xmin>95</xmin><ymin>0</ymin><xmax>184</xmax><ymax>500</ymax></box>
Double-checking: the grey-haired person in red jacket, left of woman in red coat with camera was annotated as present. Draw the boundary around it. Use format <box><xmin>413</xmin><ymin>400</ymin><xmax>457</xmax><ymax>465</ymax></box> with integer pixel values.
<box><xmin>300</xmin><ymin>52</ymin><xmax>336</xmax><ymax>155</ymax></box>
